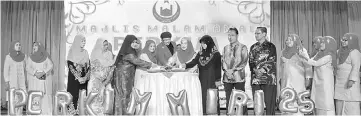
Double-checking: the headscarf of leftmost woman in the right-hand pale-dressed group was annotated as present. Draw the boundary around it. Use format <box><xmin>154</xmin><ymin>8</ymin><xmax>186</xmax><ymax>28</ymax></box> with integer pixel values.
<box><xmin>282</xmin><ymin>34</ymin><xmax>302</xmax><ymax>59</ymax></box>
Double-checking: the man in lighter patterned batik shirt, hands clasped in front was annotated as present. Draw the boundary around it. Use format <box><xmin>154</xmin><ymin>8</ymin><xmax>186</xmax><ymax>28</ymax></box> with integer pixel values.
<box><xmin>222</xmin><ymin>28</ymin><xmax>248</xmax><ymax>115</ymax></box>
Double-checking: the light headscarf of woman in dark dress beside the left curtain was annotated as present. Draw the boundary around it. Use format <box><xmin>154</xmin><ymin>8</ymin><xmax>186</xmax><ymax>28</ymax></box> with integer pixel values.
<box><xmin>68</xmin><ymin>35</ymin><xmax>89</xmax><ymax>64</ymax></box>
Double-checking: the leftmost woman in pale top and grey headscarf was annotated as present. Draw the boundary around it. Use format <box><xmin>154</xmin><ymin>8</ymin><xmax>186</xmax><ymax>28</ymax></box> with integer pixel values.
<box><xmin>4</xmin><ymin>41</ymin><xmax>26</xmax><ymax>115</ymax></box>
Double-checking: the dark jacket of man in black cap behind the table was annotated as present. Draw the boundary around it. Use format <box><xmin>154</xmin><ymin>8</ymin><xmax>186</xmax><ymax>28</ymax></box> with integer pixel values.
<box><xmin>156</xmin><ymin>41</ymin><xmax>177</xmax><ymax>66</ymax></box>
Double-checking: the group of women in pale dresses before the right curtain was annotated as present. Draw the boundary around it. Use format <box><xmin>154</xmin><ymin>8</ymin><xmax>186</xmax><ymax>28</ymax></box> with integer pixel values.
<box><xmin>279</xmin><ymin>33</ymin><xmax>361</xmax><ymax>115</ymax></box>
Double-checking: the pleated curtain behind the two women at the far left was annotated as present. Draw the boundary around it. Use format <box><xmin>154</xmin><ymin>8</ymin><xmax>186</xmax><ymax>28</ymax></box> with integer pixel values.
<box><xmin>1</xmin><ymin>1</ymin><xmax>65</xmax><ymax>104</ymax></box>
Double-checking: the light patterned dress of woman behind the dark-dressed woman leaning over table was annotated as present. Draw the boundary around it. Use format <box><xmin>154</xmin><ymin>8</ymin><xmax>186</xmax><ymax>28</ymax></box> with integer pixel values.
<box><xmin>87</xmin><ymin>60</ymin><xmax>115</xmax><ymax>115</ymax></box>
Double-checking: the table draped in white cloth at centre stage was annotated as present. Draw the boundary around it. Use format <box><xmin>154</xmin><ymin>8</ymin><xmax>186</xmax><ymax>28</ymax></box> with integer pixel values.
<box><xmin>135</xmin><ymin>71</ymin><xmax>205</xmax><ymax>115</ymax></box>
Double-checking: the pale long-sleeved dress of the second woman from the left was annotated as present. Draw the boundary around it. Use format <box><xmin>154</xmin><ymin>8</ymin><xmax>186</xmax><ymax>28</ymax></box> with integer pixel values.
<box><xmin>26</xmin><ymin>57</ymin><xmax>53</xmax><ymax>115</ymax></box>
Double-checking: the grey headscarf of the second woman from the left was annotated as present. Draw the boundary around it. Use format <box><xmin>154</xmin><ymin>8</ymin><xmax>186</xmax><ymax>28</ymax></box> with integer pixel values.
<box><xmin>30</xmin><ymin>42</ymin><xmax>49</xmax><ymax>63</ymax></box>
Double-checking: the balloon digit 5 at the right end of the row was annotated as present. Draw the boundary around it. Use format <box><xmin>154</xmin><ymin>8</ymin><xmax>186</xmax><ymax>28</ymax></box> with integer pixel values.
<box><xmin>298</xmin><ymin>91</ymin><xmax>315</xmax><ymax>114</ymax></box>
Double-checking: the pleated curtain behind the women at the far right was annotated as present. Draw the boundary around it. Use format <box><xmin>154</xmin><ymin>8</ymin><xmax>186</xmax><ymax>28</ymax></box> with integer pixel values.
<box><xmin>271</xmin><ymin>1</ymin><xmax>361</xmax><ymax>97</ymax></box>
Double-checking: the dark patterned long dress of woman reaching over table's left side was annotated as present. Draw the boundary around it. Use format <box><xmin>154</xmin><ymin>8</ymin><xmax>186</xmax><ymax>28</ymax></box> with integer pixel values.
<box><xmin>112</xmin><ymin>54</ymin><xmax>152</xmax><ymax>115</ymax></box>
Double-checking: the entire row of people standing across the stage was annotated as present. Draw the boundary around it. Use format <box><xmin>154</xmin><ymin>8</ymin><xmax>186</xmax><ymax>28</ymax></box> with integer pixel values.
<box><xmin>4</xmin><ymin>27</ymin><xmax>361</xmax><ymax>115</ymax></box>
